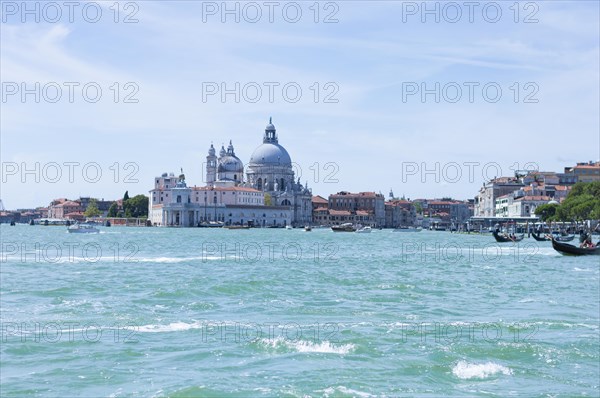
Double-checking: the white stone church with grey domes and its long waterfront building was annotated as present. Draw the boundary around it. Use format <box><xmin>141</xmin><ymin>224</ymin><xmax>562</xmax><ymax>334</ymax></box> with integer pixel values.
<box><xmin>149</xmin><ymin>120</ymin><xmax>312</xmax><ymax>227</ymax></box>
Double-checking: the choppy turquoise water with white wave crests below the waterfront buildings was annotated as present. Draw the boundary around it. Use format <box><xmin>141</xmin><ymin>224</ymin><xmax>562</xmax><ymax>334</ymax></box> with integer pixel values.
<box><xmin>0</xmin><ymin>225</ymin><xmax>600</xmax><ymax>397</ymax></box>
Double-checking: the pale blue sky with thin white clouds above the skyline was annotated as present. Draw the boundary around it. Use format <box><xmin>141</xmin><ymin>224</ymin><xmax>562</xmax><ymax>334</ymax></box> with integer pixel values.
<box><xmin>0</xmin><ymin>0</ymin><xmax>600</xmax><ymax>209</ymax></box>
